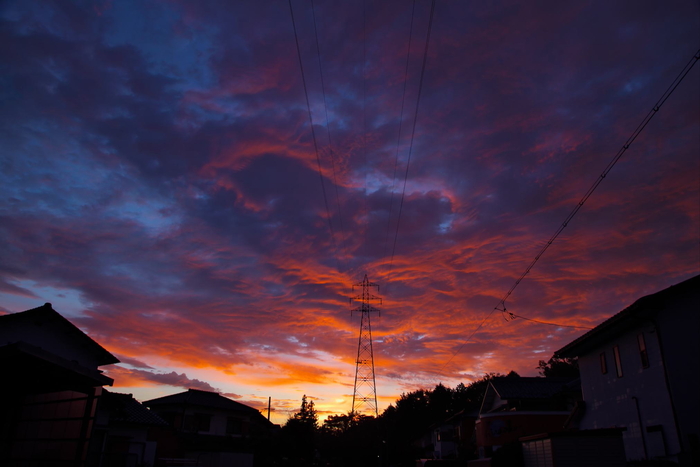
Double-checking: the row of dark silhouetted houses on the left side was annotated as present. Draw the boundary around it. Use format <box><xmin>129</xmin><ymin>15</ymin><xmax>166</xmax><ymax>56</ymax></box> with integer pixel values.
<box><xmin>0</xmin><ymin>303</ymin><xmax>274</xmax><ymax>467</ymax></box>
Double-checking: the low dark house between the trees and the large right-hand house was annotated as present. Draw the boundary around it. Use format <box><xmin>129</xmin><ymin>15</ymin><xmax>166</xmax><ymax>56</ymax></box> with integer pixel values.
<box><xmin>475</xmin><ymin>376</ymin><xmax>581</xmax><ymax>458</ymax></box>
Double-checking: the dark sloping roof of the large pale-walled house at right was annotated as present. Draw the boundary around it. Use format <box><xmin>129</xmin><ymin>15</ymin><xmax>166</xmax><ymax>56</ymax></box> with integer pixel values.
<box><xmin>554</xmin><ymin>275</ymin><xmax>700</xmax><ymax>357</ymax></box>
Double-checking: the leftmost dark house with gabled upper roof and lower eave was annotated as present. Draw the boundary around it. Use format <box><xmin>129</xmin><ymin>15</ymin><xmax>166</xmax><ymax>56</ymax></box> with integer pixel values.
<box><xmin>0</xmin><ymin>303</ymin><xmax>119</xmax><ymax>466</ymax></box>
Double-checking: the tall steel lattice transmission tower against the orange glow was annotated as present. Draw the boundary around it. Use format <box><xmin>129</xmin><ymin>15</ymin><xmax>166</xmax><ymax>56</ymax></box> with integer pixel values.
<box><xmin>350</xmin><ymin>274</ymin><xmax>382</xmax><ymax>417</ymax></box>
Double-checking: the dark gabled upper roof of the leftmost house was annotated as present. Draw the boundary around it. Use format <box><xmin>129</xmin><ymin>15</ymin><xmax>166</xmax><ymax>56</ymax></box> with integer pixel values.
<box><xmin>0</xmin><ymin>303</ymin><xmax>119</xmax><ymax>366</ymax></box>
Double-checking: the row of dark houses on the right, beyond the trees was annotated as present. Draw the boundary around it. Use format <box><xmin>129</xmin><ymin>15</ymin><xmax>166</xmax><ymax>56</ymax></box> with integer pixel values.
<box><xmin>416</xmin><ymin>276</ymin><xmax>700</xmax><ymax>467</ymax></box>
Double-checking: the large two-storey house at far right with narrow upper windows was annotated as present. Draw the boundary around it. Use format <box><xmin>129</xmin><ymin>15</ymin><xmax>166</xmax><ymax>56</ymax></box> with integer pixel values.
<box><xmin>556</xmin><ymin>276</ymin><xmax>700</xmax><ymax>465</ymax></box>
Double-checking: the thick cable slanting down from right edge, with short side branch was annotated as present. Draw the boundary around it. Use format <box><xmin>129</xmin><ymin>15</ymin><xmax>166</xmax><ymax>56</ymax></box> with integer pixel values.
<box><xmin>440</xmin><ymin>50</ymin><xmax>700</xmax><ymax>373</ymax></box>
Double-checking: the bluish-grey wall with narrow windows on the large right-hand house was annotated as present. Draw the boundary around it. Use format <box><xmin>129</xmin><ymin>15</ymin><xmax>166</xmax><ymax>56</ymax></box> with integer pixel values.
<box><xmin>579</xmin><ymin>322</ymin><xmax>680</xmax><ymax>460</ymax></box>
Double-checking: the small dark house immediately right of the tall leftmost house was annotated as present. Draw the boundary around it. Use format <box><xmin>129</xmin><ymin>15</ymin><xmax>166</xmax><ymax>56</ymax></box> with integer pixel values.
<box><xmin>88</xmin><ymin>390</ymin><xmax>175</xmax><ymax>467</ymax></box>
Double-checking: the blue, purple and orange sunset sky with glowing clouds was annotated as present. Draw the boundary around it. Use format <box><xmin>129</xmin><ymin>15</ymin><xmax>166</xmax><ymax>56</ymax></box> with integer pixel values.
<box><xmin>0</xmin><ymin>0</ymin><xmax>700</xmax><ymax>423</ymax></box>
